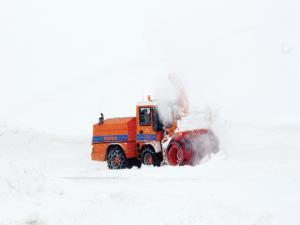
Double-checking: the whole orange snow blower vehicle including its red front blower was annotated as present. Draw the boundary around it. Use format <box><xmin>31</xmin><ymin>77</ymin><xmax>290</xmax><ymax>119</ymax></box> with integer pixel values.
<box><xmin>91</xmin><ymin>98</ymin><xmax>218</xmax><ymax>169</ymax></box>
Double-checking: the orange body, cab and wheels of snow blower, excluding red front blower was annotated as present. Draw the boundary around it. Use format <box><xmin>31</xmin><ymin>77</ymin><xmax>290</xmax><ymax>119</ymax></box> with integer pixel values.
<box><xmin>92</xmin><ymin>102</ymin><xmax>164</xmax><ymax>169</ymax></box>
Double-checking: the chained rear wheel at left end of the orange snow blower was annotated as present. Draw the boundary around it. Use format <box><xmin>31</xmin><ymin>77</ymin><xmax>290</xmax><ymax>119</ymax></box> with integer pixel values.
<box><xmin>107</xmin><ymin>146</ymin><xmax>127</xmax><ymax>170</ymax></box>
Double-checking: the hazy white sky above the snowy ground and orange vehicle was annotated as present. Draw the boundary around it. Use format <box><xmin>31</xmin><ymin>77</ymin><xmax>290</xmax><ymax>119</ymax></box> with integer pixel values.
<box><xmin>0</xmin><ymin>0</ymin><xmax>300</xmax><ymax>134</ymax></box>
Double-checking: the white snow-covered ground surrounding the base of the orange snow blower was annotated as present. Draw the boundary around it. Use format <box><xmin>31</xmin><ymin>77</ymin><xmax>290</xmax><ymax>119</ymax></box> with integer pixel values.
<box><xmin>0</xmin><ymin>124</ymin><xmax>300</xmax><ymax>225</ymax></box>
